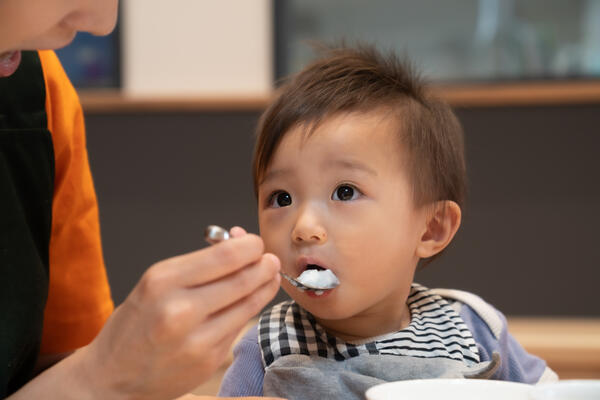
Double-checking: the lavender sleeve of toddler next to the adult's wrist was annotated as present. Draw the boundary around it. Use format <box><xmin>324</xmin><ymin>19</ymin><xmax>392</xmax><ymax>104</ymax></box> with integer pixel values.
<box><xmin>214</xmin><ymin>325</ymin><xmax>265</xmax><ymax>397</ymax></box>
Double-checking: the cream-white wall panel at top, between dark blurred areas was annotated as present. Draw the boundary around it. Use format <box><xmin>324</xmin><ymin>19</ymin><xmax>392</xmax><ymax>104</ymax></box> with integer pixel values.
<box><xmin>121</xmin><ymin>0</ymin><xmax>273</xmax><ymax>97</ymax></box>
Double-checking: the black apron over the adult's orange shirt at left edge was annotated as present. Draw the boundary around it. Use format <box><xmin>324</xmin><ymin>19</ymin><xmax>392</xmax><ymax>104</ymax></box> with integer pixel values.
<box><xmin>0</xmin><ymin>52</ymin><xmax>54</xmax><ymax>398</ymax></box>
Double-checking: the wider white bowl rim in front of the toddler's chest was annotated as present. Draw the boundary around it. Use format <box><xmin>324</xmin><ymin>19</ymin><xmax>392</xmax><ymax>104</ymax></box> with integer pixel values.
<box><xmin>366</xmin><ymin>379</ymin><xmax>532</xmax><ymax>400</ymax></box>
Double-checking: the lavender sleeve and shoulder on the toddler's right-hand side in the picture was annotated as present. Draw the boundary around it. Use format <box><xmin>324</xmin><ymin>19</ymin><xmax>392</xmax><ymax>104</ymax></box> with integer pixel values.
<box><xmin>460</xmin><ymin>304</ymin><xmax>553</xmax><ymax>384</ymax></box>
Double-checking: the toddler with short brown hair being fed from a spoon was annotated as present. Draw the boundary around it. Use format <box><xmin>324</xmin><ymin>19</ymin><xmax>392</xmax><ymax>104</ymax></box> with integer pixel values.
<box><xmin>220</xmin><ymin>46</ymin><xmax>557</xmax><ymax>400</ymax></box>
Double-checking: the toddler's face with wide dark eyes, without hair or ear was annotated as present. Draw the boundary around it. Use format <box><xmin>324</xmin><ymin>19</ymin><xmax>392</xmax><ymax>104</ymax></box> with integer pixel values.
<box><xmin>258</xmin><ymin>112</ymin><xmax>426</xmax><ymax>333</ymax></box>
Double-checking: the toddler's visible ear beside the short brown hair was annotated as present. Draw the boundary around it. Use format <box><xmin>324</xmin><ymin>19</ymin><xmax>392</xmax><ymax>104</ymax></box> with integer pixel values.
<box><xmin>417</xmin><ymin>200</ymin><xmax>462</xmax><ymax>258</ymax></box>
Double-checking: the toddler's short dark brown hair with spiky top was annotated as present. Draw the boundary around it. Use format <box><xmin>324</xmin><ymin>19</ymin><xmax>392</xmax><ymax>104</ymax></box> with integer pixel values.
<box><xmin>252</xmin><ymin>45</ymin><xmax>466</xmax><ymax>217</ymax></box>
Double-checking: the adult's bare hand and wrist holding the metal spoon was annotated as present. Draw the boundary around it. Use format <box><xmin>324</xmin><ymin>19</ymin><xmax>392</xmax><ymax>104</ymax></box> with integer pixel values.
<box><xmin>9</xmin><ymin>228</ymin><xmax>280</xmax><ymax>400</ymax></box>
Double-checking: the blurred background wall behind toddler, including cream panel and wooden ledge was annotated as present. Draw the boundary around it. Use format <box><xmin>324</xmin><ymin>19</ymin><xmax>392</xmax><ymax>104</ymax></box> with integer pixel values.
<box><xmin>58</xmin><ymin>0</ymin><xmax>600</xmax><ymax>317</ymax></box>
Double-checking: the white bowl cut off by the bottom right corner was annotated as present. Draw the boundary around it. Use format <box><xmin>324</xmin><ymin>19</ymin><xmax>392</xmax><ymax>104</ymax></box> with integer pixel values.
<box><xmin>531</xmin><ymin>379</ymin><xmax>600</xmax><ymax>400</ymax></box>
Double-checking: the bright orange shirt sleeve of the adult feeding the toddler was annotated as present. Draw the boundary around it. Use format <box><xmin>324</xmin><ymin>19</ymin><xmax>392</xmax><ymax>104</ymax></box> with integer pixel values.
<box><xmin>38</xmin><ymin>51</ymin><xmax>114</xmax><ymax>358</ymax></box>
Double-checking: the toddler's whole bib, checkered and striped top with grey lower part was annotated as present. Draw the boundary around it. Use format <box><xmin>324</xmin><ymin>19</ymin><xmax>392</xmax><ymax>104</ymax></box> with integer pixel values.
<box><xmin>259</xmin><ymin>284</ymin><xmax>498</xmax><ymax>400</ymax></box>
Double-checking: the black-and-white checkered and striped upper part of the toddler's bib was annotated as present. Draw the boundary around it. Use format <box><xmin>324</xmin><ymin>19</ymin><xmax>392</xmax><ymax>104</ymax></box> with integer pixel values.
<box><xmin>258</xmin><ymin>283</ymin><xmax>480</xmax><ymax>367</ymax></box>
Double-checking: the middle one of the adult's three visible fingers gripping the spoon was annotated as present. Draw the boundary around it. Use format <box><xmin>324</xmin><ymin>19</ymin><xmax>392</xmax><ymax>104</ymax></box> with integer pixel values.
<box><xmin>185</xmin><ymin>254</ymin><xmax>281</xmax><ymax>315</ymax></box>
